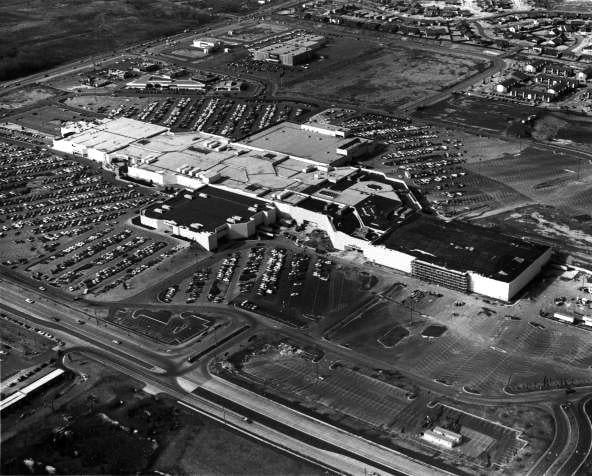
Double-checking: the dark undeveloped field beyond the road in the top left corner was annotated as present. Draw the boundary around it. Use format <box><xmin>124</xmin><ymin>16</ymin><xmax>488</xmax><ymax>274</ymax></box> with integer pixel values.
<box><xmin>0</xmin><ymin>0</ymin><xmax>256</xmax><ymax>81</ymax></box>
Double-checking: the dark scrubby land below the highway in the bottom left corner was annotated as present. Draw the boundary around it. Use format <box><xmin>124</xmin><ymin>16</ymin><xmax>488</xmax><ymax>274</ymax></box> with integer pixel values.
<box><xmin>1</xmin><ymin>355</ymin><xmax>322</xmax><ymax>475</ymax></box>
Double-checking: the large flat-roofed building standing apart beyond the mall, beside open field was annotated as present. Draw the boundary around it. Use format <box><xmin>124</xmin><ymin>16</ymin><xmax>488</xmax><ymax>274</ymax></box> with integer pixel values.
<box><xmin>251</xmin><ymin>33</ymin><xmax>325</xmax><ymax>66</ymax></box>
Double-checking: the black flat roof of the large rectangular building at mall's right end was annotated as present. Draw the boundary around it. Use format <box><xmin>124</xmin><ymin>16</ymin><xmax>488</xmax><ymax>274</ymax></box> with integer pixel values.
<box><xmin>375</xmin><ymin>214</ymin><xmax>549</xmax><ymax>282</ymax></box>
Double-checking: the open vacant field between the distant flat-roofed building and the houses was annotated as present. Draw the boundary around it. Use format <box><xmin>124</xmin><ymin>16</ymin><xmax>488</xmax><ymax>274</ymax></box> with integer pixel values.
<box><xmin>283</xmin><ymin>39</ymin><xmax>482</xmax><ymax>110</ymax></box>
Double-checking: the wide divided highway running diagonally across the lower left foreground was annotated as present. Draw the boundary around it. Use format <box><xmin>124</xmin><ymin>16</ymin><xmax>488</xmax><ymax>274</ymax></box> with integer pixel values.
<box><xmin>0</xmin><ymin>276</ymin><xmax>452</xmax><ymax>475</ymax></box>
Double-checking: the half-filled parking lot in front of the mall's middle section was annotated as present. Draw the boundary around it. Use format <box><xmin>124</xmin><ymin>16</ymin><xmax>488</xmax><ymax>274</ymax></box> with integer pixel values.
<box><xmin>153</xmin><ymin>240</ymin><xmax>376</xmax><ymax>328</ymax></box>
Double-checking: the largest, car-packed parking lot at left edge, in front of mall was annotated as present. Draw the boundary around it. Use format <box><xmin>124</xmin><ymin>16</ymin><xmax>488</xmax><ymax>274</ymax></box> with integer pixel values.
<box><xmin>0</xmin><ymin>143</ymin><xmax>190</xmax><ymax>295</ymax></box>
